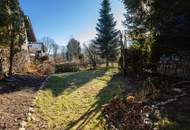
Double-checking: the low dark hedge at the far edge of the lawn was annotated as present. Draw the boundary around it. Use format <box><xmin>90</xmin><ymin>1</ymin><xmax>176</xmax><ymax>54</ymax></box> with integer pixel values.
<box><xmin>55</xmin><ymin>63</ymin><xmax>79</xmax><ymax>73</ymax></box>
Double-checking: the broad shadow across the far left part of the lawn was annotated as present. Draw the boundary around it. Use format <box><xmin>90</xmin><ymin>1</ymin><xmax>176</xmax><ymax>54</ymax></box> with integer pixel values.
<box><xmin>44</xmin><ymin>69</ymin><xmax>106</xmax><ymax>97</ymax></box>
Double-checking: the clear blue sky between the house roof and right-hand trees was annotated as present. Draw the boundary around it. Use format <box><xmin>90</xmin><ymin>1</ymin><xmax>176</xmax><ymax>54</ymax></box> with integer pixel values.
<box><xmin>20</xmin><ymin>0</ymin><xmax>124</xmax><ymax>45</ymax></box>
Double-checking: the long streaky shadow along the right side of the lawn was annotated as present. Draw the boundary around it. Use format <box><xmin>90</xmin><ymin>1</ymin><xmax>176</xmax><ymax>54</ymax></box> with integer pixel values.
<box><xmin>64</xmin><ymin>74</ymin><xmax>124</xmax><ymax>130</ymax></box>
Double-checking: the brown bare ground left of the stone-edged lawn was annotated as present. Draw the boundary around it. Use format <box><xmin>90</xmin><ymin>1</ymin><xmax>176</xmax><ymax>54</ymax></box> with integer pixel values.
<box><xmin>0</xmin><ymin>75</ymin><xmax>45</xmax><ymax>130</ymax></box>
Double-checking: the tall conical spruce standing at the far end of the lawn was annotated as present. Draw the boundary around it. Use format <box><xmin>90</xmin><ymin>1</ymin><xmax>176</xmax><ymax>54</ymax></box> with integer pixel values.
<box><xmin>93</xmin><ymin>0</ymin><xmax>119</xmax><ymax>67</ymax></box>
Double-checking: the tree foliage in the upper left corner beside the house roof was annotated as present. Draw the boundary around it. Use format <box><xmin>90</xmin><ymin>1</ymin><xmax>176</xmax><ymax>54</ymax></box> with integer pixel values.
<box><xmin>0</xmin><ymin>0</ymin><xmax>25</xmax><ymax>45</ymax></box>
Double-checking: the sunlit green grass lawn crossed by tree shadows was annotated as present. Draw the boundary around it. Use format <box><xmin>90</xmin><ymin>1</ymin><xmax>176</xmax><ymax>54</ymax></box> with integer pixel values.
<box><xmin>28</xmin><ymin>69</ymin><xmax>124</xmax><ymax>130</ymax></box>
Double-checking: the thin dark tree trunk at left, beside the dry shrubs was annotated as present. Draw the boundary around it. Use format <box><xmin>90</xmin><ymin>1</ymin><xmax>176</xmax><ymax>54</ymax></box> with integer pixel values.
<box><xmin>9</xmin><ymin>41</ymin><xmax>14</xmax><ymax>76</ymax></box>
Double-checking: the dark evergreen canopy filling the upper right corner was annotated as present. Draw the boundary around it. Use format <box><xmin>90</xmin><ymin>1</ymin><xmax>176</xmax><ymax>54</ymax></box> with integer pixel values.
<box><xmin>123</xmin><ymin>0</ymin><xmax>190</xmax><ymax>61</ymax></box>
